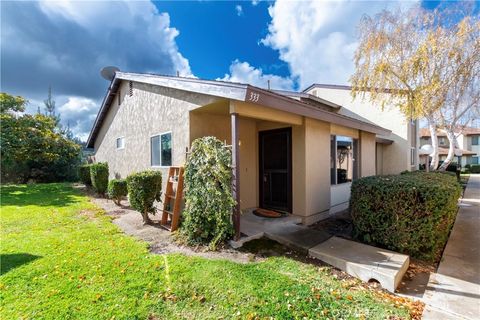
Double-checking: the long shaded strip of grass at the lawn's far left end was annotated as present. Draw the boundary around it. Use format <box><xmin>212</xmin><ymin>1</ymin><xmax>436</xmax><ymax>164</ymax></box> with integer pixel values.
<box><xmin>1</xmin><ymin>183</ymin><xmax>78</xmax><ymax>207</ymax></box>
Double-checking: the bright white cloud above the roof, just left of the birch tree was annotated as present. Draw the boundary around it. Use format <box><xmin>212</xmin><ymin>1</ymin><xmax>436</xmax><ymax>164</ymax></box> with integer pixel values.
<box><xmin>261</xmin><ymin>0</ymin><xmax>413</xmax><ymax>89</ymax></box>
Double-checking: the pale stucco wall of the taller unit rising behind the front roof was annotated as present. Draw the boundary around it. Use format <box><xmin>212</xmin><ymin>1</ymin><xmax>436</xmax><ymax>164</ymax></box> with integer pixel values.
<box><xmin>309</xmin><ymin>88</ymin><xmax>418</xmax><ymax>174</ymax></box>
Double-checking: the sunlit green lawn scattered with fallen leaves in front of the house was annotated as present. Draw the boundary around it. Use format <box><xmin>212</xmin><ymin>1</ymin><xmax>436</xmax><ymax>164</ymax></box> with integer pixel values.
<box><xmin>0</xmin><ymin>184</ymin><xmax>409</xmax><ymax>319</ymax></box>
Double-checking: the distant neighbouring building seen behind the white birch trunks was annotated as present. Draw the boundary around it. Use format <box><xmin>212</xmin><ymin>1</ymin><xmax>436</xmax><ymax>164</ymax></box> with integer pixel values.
<box><xmin>420</xmin><ymin>127</ymin><xmax>480</xmax><ymax>166</ymax></box>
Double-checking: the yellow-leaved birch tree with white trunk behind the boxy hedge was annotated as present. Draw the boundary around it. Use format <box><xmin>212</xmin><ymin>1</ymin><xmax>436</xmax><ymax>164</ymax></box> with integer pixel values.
<box><xmin>351</xmin><ymin>6</ymin><xmax>478</xmax><ymax>169</ymax></box>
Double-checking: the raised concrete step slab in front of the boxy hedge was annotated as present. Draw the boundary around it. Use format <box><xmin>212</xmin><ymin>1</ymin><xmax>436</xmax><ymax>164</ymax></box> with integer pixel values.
<box><xmin>308</xmin><ymin>237</ymin><xmax>410</xmax><ymax>292</ymax></box>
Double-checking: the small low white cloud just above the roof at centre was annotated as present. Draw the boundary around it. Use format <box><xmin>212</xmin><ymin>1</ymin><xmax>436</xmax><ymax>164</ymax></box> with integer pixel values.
<box><xmin>217</xmin><ymin>60</ymin><xmax>294</xmax><ymax>90</ymax></box>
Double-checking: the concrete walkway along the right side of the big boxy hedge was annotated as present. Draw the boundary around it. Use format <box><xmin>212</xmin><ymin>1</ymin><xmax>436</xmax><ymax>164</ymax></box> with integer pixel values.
<box><xmin>423</xmin><ymin>174</ymin><xmax>480</xmax><ymax>320</ymax></box>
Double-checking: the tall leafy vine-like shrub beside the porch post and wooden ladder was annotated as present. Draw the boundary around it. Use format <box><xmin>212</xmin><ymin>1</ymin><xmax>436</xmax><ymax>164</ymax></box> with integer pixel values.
<box><xmin>181</xmin><ymin>137</ymin><xmax>235</xmax><ymax>249</ymax></box>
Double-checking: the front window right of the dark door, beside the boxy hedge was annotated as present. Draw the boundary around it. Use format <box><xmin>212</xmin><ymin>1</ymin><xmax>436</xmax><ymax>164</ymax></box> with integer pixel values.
<box><xmin>330</xmin><ymin>136</ymin><xmax>358</xmax><ymax>184</ymax></box>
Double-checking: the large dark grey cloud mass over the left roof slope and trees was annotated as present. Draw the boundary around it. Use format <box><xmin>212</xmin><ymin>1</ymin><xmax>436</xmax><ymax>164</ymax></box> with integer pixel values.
<box><xmin>1</xmin><ymin>1</ymin><xmax>192</xmax><ymax>138</ymax></box>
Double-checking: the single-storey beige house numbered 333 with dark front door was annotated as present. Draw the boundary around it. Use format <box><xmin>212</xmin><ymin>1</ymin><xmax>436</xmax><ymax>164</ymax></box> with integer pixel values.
<box><xmin>87</xmin><ymin>72</ymin><xmax>417</xmax><ymax>224</ymax></box>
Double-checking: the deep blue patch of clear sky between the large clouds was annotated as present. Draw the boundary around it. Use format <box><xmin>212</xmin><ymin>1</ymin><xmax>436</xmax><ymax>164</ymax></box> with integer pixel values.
<box><xmin>155</xmin><ymin>1</ymin><xmax>289</xmax><ymax>79</ymax></box>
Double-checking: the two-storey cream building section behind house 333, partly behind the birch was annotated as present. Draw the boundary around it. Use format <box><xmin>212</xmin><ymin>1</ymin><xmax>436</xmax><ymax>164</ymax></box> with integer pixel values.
<box><xmin>304</xmin><ymin>84</ymin><xmax>419</xmax><ymax>175</ymax></box>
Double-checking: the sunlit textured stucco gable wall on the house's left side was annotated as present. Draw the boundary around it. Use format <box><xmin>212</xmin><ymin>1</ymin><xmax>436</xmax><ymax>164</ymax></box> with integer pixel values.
<box><xmin>94</xmin><ymin>81</ymin><xmax>216</xmax><ymax>190</ymax></box>
